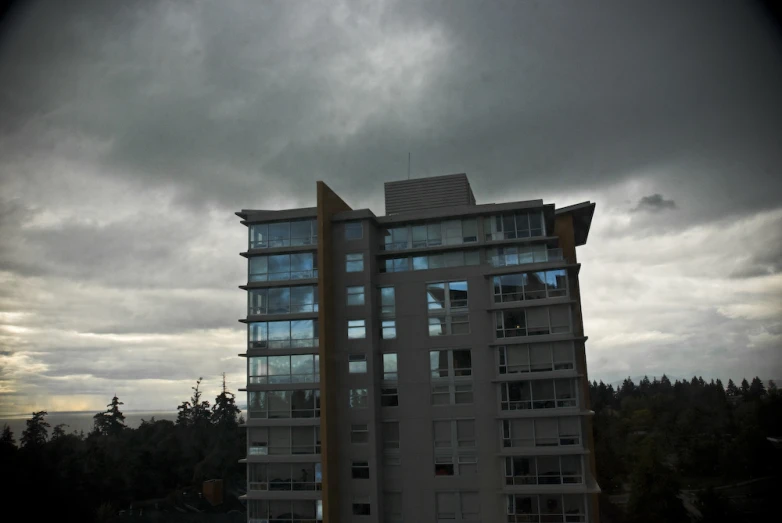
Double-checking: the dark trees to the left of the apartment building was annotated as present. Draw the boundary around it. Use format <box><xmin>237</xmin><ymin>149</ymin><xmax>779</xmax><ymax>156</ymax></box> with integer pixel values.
<box><xmin>0</xmin><ymin>377</ymin><xmax>246</xmax><ymax>521</ymax></box>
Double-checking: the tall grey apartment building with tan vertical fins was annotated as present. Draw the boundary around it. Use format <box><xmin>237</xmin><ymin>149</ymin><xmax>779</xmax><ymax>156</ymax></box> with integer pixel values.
<box><xmin>236</xmin><ymin>174</ymin><xmax>599</xmax><ymax>523</ymax></box>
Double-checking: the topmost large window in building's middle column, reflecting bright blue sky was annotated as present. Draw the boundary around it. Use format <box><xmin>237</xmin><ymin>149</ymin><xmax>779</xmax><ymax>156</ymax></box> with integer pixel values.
<box><xmin>426</xmin><ymin>281</ymin><xmax>470</xmax><ymax>336</ymax></box>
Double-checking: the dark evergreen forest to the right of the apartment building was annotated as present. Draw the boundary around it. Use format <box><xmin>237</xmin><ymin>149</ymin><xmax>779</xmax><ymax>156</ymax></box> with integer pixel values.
<box><xmin>590</xmin><ymin>375</ymin><xmax>782</xmax><ymax>523</ymax></box>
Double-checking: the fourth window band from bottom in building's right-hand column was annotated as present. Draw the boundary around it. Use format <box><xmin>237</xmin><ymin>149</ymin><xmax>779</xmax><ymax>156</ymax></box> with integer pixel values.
<box><xmin>500</xmin><ymin>379</ymin><xmax>578</xmax><ymax>410</ymax></box>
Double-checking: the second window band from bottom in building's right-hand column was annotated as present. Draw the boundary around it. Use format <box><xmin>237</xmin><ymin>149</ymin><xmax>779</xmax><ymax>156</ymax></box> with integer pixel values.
<box><xmin>505</xmin><ymin>455</ymin><xmax>584</xmax><ymax>485</ymax></box>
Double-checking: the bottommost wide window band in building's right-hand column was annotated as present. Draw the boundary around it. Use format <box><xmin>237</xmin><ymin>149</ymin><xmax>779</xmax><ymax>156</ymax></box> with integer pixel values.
<box><xmin>507</xmin><ymin>494</ymin><xmax>587</xmax><ymax>523</ymax></box>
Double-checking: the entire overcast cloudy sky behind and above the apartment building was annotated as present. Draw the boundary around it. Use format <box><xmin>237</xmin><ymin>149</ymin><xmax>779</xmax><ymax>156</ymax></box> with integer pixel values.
<box><xmin>0</xmin><ymin>0</ymin><xmax>782</xmax><ymax>415</ymax></box>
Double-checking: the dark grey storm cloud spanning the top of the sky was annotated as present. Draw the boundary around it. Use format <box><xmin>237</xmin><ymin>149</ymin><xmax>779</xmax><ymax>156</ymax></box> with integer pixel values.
<box><xmin>0</xmin><ymin>1</ymin><xmax>782</xmax><ymax>223</ymax></box>
